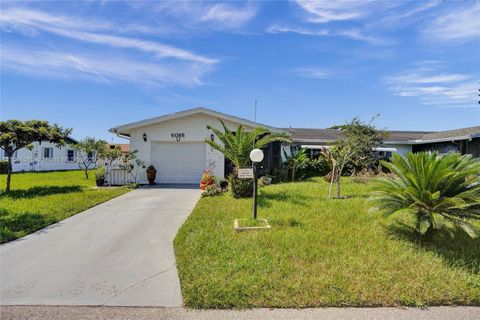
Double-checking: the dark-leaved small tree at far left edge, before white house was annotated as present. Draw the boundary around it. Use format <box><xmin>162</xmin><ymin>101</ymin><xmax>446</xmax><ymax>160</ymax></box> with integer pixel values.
<box><xmin>0</xmin><ymin>120</ymin><xmax>72</xmax><ymax>192</ymax></box>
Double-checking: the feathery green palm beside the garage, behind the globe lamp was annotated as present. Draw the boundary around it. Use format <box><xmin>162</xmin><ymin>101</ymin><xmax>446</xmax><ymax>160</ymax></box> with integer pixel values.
<box><xmin>205</xmin><ymin>120</ymin><xmax>292</xmax><ymax>169</ymax></box>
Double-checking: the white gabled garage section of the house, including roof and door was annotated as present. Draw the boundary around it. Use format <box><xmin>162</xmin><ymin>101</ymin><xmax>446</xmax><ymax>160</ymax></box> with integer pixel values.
<box><xmin>109</xmin><ymin>108</ymin><xmax>284</xmax><ymax>183</ymax></box>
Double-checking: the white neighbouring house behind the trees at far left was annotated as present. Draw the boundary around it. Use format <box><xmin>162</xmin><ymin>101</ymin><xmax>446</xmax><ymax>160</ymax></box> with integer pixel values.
<box><xmin>0</xmin><ymin>137</ymin><xmax>86</xmax><ymax>172</ymax></box>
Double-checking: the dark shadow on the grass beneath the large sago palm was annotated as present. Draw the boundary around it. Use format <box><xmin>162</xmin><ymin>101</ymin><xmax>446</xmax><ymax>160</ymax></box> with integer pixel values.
<box><xmin>388</xmin><ymin>223</ymin><xmax>480</xmax><ymax>275</ymax></box>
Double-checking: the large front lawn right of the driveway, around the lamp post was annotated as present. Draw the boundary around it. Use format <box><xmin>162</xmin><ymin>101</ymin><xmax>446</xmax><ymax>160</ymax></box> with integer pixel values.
<box><xmin>175</xmin><ymin>179</ymin><xmax>480</xmax><ymax>308</ymax></box>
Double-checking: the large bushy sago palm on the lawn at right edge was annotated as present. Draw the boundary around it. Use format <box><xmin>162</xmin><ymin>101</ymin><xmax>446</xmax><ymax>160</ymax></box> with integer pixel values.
<box><xmin>370</xmin><ymin>152</ymin><xmax>480</xmax><ymax>238</ymax></box>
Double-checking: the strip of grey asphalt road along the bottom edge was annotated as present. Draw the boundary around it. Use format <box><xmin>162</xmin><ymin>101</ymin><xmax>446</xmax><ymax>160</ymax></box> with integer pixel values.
<box><xmin>0</xmin><ymin>306</ymin><xmax>480</xmax><ymax>320</ymax></box>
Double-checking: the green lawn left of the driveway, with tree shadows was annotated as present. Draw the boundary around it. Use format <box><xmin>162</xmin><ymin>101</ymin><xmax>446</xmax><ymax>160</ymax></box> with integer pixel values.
<box><xmin>0</xmin><ymin>171</ymin><xmax>129</xmax><ymax>243</ymax></box>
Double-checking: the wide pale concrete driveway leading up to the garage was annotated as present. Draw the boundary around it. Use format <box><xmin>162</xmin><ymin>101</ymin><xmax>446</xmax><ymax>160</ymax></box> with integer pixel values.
<box><xmin>0</xmin><ymin>187</ymin><xmax>200</xmax><ymax>307</ymax></box>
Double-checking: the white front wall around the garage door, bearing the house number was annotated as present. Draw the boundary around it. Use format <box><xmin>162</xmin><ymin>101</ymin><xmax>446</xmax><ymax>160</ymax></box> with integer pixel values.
<box><xmin>130</xmin><ymin>114</ymin><xmax>252</xmax><ymax>183</ymax></box>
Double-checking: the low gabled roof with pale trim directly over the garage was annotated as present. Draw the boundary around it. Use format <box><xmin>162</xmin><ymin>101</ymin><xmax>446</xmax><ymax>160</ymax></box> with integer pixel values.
<box><xmin>108</xmin><ymin>107</ymin><xmax>283</xmax><ymax>135</ymax></box>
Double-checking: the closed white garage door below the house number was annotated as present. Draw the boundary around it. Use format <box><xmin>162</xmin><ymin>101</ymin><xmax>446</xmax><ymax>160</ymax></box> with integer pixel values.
<box><xmin>151</xmin><ymin>142</ymin><xmax>206</xmax><ymax>183</ymax></box>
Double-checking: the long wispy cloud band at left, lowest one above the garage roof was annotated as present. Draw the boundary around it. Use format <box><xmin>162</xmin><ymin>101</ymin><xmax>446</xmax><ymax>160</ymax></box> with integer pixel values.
<box><xmin>2</xmin><ymin>46</ymin><xmax>209</xmax><ymax>86</ymax></box>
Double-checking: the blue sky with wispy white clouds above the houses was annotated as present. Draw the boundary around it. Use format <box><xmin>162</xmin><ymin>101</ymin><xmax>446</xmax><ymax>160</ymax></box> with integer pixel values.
<box><xmin>0</xmin><ymin>1</ymin><xmax>480</xmax><ymax>141</ymax></box>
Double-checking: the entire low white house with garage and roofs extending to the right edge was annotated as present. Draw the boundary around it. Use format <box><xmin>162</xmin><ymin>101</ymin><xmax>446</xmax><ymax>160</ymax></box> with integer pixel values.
<box><xmin>109</xmin><ymin>108</ymin><xmax>480</xmax><ymax>183</ymax></box>
